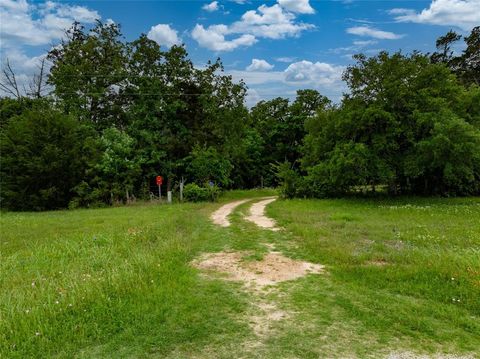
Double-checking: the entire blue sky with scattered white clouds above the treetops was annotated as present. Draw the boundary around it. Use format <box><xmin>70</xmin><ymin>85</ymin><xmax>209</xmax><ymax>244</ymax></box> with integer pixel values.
<box><xmin>0</xmin><ymin>0</ymin><xmax>480</xmax><ymax>105</ymax></box>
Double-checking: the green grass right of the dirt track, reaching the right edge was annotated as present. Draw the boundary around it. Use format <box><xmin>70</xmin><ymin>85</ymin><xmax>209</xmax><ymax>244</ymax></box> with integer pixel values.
<box><xmin>269</xmin><ymin>198</ymin><xmax>480</xmax><ymax>357</ymax></box>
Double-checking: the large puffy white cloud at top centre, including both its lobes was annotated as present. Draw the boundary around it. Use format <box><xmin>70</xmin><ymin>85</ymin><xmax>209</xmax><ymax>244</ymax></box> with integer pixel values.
<box><xmin>192</xmin><ymin>4</ymin><xmax>314</xmax><ymax>51</ymax></box>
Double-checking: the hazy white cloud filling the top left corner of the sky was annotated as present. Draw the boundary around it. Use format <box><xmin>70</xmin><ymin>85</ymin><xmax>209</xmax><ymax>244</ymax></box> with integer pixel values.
<box><xmin>0</xmin><ymin>0</ymin><xmax>100</xmax><ymax>47</ymax></box>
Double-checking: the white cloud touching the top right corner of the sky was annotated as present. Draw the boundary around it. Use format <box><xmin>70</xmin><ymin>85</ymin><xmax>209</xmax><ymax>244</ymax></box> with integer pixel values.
<box><xmin>390</xmin><ymin>0</ymin><xmax>480</xmax><ymax>31</ymax></box>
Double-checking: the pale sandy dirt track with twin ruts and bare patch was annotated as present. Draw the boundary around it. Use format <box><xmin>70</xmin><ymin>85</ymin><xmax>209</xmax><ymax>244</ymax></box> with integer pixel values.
<box><xmin>205</xmin><ymin>197</ymin><xmax>324</xmax><ymax>352</ymax></box>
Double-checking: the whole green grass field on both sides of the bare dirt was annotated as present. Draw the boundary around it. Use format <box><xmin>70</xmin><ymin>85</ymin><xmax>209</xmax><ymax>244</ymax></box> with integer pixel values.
<box><xmin>0</xmin><ymin>191</ymin><xmax>480</xmax><ymax>358</ymax></box>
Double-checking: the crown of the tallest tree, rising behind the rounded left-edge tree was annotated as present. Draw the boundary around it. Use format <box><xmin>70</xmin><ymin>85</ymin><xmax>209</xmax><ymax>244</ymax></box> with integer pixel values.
<box><xmin>48</xmin><ymin>21</ymin><xmax>127</xmax><ymax>132</ymax></box>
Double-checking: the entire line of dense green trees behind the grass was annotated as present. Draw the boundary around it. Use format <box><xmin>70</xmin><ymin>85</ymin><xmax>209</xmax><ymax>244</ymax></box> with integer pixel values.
<box><xmin>0</xmin><ymin>22</ymin><xmax>480</xmax><ymax>210</ymax></box>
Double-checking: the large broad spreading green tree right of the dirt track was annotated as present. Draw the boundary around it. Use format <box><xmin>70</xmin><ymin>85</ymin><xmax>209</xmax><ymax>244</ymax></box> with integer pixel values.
<box><xmin>302</xmin><ymin>52</ymin><xmax>480</xmax><ymax>196</ymax></box>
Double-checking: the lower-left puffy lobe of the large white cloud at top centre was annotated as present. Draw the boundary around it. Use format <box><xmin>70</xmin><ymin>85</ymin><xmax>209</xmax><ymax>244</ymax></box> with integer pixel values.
<box><xmin>192</xmin><ymin>24</ymin><xmax>257</xmax><ymax>52</ymax></box>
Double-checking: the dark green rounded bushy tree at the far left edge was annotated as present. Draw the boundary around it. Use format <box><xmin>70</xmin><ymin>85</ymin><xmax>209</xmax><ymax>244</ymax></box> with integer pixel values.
<box><xmin>0</xmin><ymin>107</ymin><xmax>92</xmax><ymax>210</ymax></box>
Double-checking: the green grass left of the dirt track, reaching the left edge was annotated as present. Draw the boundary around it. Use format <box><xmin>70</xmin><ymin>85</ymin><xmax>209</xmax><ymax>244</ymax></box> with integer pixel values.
<box><xmin>0</xmin><ymin>192</ymin><xmax>274</xmax><ymax>358</ymax></box>
